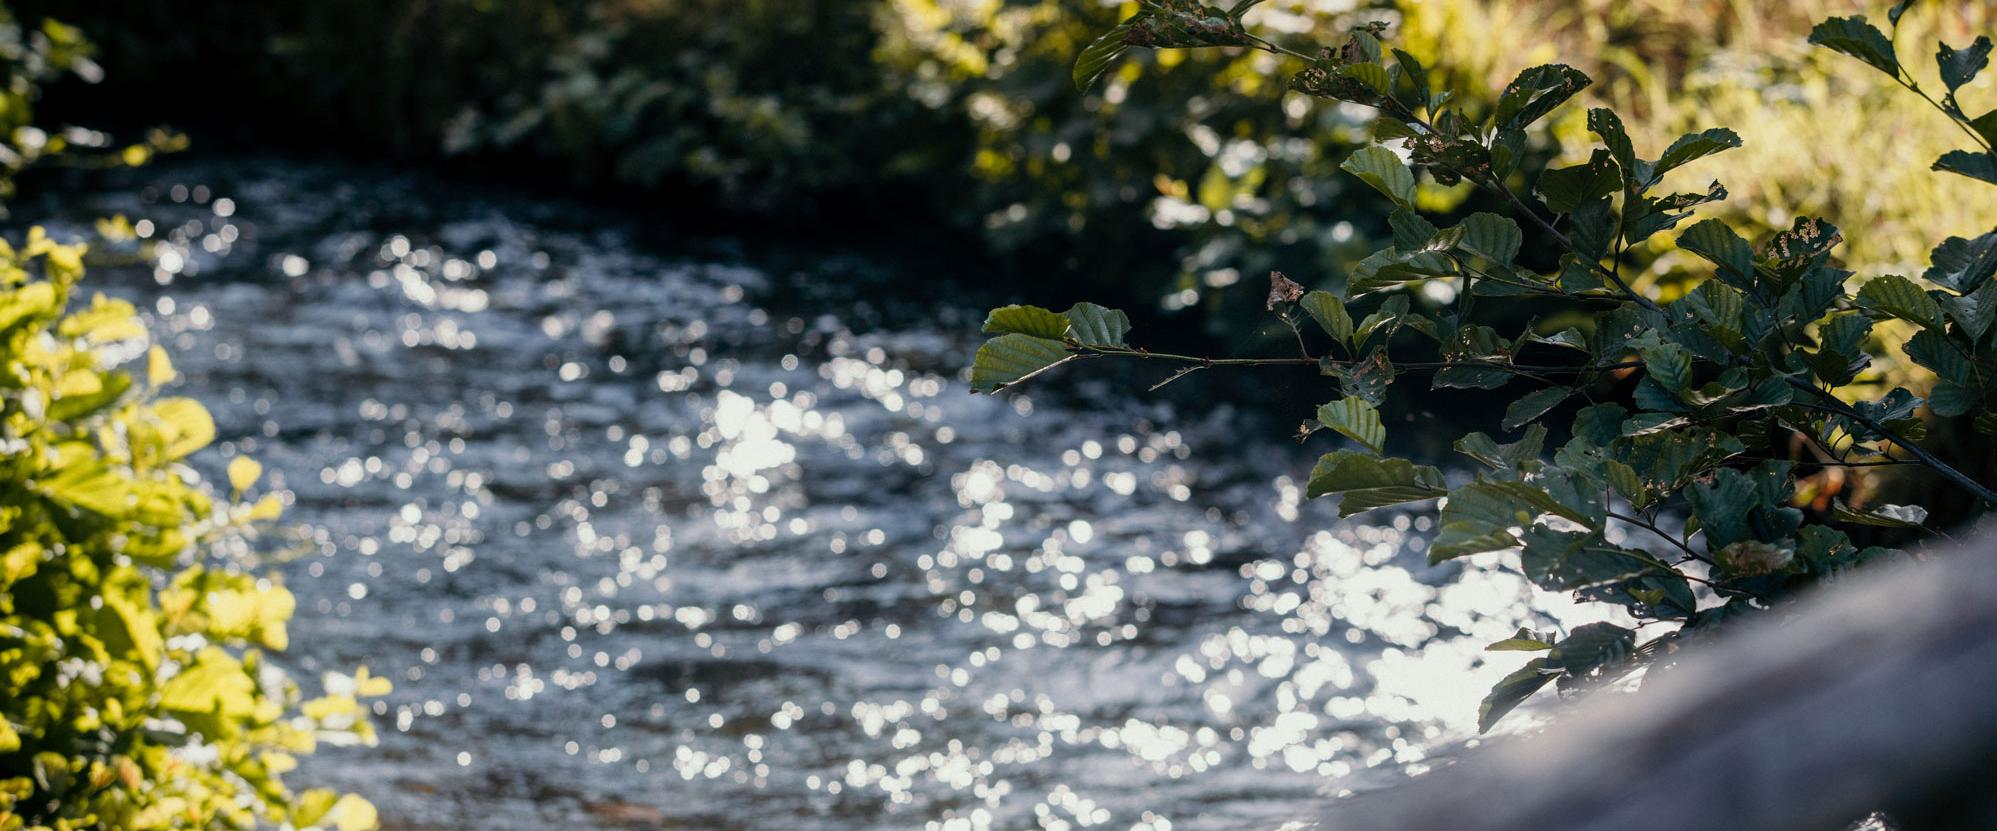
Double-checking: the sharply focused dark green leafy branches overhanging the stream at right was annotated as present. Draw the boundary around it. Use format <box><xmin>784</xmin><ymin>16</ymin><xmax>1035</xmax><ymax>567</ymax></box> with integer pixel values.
<box><xmin>973</xmin><ymin>6</ymin><xmax>1997</xmax><ymax>729</ymax></box>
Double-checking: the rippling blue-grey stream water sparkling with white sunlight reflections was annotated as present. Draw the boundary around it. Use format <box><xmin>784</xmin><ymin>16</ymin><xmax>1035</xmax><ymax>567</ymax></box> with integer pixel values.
<box><xmin>14</xmin><ymin>160</ymin><xmax>1613</xmax><ymax>831</ymax></box>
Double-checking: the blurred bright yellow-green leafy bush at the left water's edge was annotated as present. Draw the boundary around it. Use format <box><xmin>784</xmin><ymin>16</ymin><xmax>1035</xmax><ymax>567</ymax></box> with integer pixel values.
<box><xmin>0</xmin><ymin>228</ymin><xmax>387</xmax><ymax>831</ymax></box>
